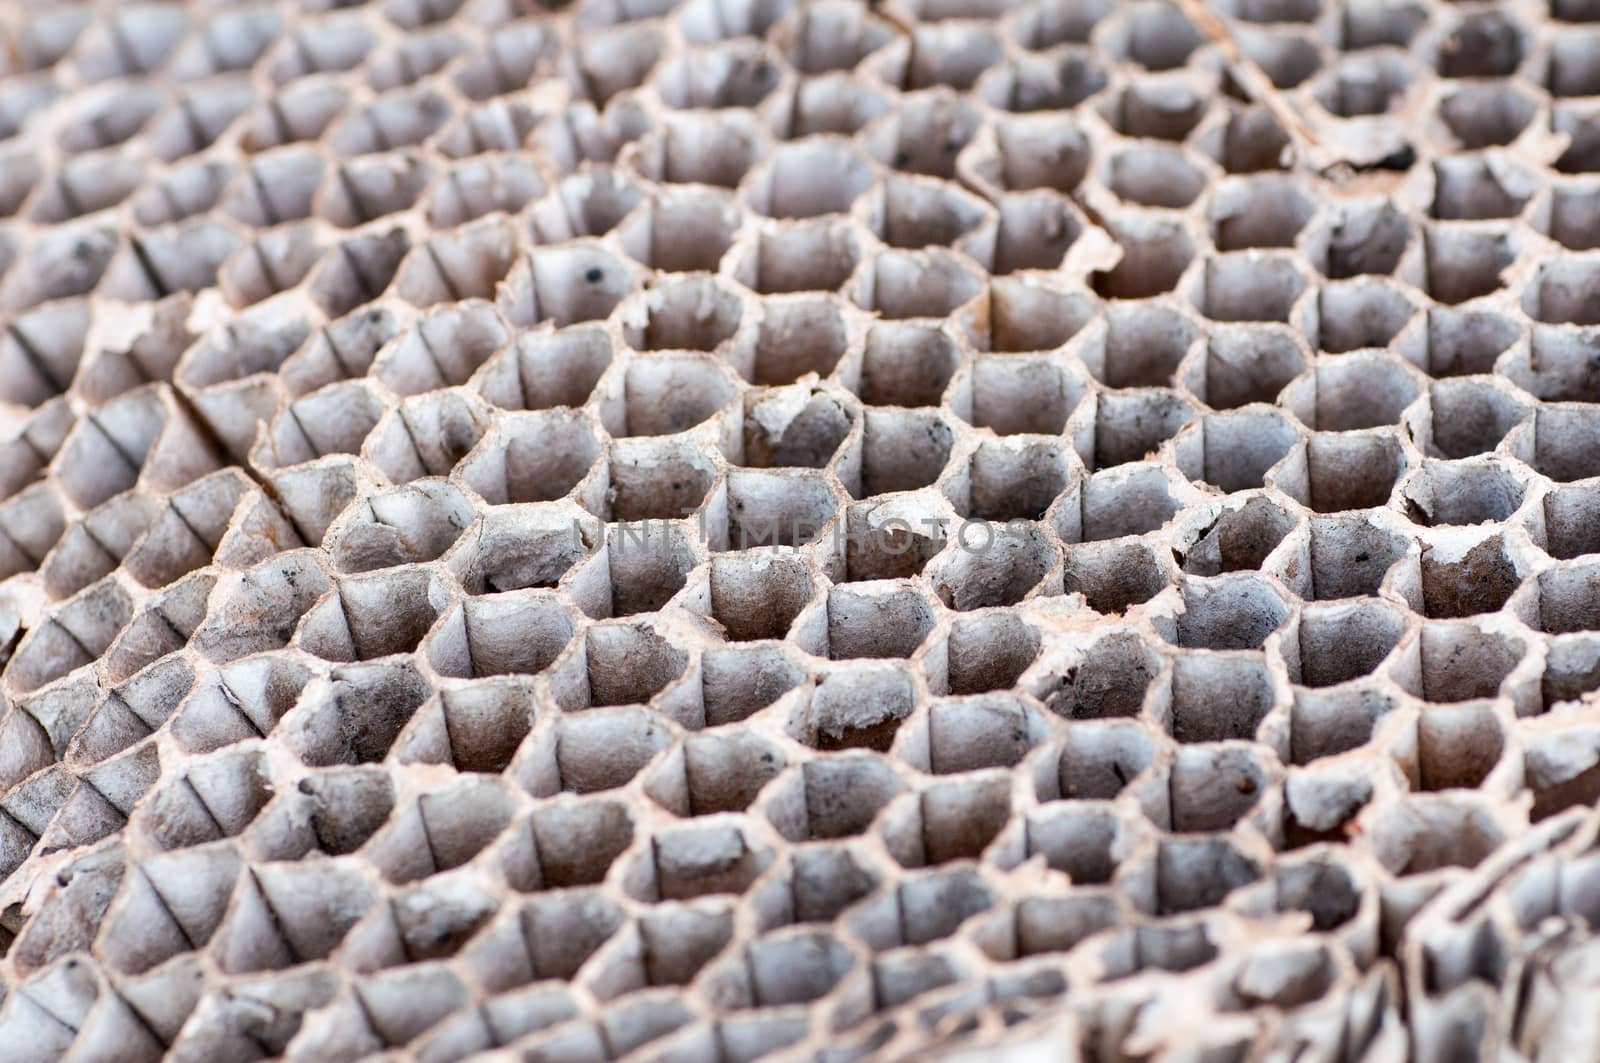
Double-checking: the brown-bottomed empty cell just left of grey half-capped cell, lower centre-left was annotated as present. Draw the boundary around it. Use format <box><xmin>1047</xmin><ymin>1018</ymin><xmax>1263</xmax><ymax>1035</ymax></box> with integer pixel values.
<box><xmin>501</xmin><ymin>797</ymin><xmax>634</xmax><ymax>893</ymax></box>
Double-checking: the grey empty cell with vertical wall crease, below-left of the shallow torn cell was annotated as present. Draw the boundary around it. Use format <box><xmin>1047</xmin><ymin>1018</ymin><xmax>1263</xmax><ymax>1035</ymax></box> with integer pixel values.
<box><xmin>299</xmin><ymin>567</ymin><xmax>438</xmax><ymax>661</ymax></box>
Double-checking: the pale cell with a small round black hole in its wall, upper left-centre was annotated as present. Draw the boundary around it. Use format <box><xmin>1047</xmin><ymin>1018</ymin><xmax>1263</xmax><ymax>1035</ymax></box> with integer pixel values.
<box><xmin>499</xmin><ymin>242</ymin><xmax>634</xmax><ymax>328</ymax></box>
